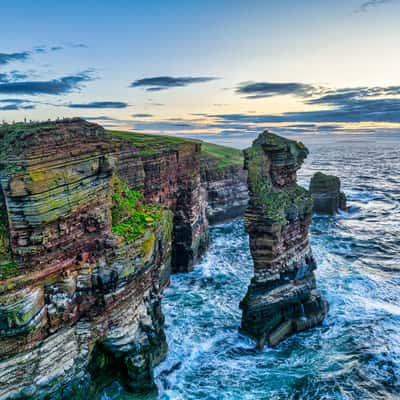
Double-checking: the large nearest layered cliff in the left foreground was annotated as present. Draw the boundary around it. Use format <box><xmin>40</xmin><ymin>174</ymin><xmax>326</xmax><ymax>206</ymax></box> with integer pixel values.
<box><xmin>0</xmin><ymin>120</ymin><xmax>173</xmax><ymax>399</ymax></box>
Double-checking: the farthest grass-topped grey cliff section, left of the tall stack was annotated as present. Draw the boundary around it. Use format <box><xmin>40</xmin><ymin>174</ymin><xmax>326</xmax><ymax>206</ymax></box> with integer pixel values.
<box><xmin>201</xmin><ymin>143</ymin><xmax>249</xmax><ymax>224</ymax></box>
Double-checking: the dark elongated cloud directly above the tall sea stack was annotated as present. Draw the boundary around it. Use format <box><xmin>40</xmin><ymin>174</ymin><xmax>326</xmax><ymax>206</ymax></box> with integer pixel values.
<box><xmin>236</xmin><ymin>82</ymin><xmax>321</xmax><ymax>99</ymax></box>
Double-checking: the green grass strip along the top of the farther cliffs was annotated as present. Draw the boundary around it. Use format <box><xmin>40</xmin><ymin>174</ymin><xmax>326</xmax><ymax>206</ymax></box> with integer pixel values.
<box><xmin>107</xmin><ymin>131</ymin><xmax>243</xmax><ymax>169</ymax></box>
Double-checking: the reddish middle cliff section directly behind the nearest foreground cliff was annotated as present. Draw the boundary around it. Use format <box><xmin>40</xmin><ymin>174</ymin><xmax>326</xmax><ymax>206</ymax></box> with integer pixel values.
<box><xmin>111</xmin><ymin>132</ymin><xmax>208</xmax><ymax>272</ymax></box>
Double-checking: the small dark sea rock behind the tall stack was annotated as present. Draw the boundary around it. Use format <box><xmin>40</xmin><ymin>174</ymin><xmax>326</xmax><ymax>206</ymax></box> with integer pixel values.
<box><xmin>310</xmin><ymin>172</ymin><xmax>347</xmax><ymax>215</ymax></box>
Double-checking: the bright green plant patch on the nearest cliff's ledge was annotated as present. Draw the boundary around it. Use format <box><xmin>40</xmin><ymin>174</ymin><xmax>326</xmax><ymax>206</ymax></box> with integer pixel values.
<box><xmin>112</xmin><ymin>178</ymin><xmax>163</xmax><ymax>243</ymax></box>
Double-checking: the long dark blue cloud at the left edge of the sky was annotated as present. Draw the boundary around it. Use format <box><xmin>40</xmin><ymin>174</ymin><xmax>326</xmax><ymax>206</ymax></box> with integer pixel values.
<box><xmin>0</xmin><ymin>72</ymin><xmax>93</xmax><ymax>95</ymax></box>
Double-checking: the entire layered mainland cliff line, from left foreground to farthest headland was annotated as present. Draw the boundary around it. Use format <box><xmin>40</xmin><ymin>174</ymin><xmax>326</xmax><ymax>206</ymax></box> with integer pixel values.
<box><xmin>0</xmin><ymin>119</ymin><xmax>247</xmax><ymax>400</ymax></box>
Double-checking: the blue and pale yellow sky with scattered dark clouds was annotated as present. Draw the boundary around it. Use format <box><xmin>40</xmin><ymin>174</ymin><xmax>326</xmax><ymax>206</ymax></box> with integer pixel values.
<box><xmin>0</xmin><ymin>0</ymin><xmax>400</xmax><ymax>138</ymax></box>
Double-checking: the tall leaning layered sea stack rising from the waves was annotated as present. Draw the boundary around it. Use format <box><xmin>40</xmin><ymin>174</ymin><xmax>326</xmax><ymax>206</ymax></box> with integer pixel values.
<box><xmin>240</xmin><ymin>131</ymin><xmax>328</xmax><ymax>347</ymax></box>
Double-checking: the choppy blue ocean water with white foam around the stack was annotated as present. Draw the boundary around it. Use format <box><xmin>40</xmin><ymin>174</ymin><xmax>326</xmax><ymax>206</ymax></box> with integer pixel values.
<box><xmin>156</xmin><ymin>140</ymin><xmax>400</xmax><ymax>400</ymax></box>
